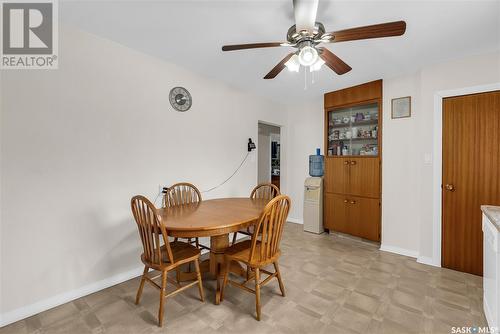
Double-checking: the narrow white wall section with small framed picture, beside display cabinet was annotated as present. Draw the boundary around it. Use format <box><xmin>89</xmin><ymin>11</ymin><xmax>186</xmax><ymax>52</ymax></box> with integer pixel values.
<box><xmin>381</xmin><ymin>73</ymin><xmax>421</xmax><ymax>256</ymax></box>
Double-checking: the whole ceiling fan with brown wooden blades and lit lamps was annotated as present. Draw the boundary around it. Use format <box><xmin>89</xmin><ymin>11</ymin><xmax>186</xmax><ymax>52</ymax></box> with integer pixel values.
<box><xmin>222</xmin><ymin>0</ymin><xmax>406</xmax><ymax>79</ymax></box>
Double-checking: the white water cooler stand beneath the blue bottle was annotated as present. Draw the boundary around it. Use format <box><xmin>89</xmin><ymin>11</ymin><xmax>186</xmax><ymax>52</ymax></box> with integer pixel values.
<box><xmin>304</xmin><ymin>177</ymin><xmax>325</xmax><ymax>234</ymax></box>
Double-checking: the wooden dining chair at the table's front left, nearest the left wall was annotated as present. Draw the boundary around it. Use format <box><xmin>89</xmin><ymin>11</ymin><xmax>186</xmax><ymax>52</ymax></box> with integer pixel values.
<box><xmin>131</xmin><ymin>196</ymin><xmax>205</xmax><ymax>327</ymax></box>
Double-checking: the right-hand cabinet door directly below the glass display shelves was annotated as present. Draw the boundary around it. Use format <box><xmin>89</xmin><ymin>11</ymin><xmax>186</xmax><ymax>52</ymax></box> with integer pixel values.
<box><xmin>347</xmin><ymin>158</ymin><xmax>380</xmax><ymax>198</ymax></box>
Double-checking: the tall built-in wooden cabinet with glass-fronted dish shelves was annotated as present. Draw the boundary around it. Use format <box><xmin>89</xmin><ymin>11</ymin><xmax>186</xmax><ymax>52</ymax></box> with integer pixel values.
<box><xmin>324</xmin><ymin>80</ymin><xmax>382</xmax><ymax>241</ymax></box>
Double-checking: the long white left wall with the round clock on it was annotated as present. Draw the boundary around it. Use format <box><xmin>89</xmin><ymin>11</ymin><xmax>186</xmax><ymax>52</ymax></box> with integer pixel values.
<box><xmin>0</xmin><ymin>26</ymin><xmax>286</xmax><ymax>323</ymax></box>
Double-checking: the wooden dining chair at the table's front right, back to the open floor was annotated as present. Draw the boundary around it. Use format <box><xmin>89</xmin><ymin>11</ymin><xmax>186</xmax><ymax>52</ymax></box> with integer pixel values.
<box><xmin>221</xmin><ymin>195</ymin><xmax>290</xmax><ymax>320</ymax></box>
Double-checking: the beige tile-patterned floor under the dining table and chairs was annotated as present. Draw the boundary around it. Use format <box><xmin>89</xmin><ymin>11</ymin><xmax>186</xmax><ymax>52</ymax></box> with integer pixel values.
<box><xmin>0</xmin><ymin>224</ymin><xmax>486</xmax><ymax>334</ymax></box>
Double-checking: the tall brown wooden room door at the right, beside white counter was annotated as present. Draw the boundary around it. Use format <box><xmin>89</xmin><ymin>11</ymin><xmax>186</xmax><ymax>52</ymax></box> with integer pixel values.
<box><xmin>441</xmin><ymin>91</ymin><xmax>500</xmax><ymax>275</ymax></box>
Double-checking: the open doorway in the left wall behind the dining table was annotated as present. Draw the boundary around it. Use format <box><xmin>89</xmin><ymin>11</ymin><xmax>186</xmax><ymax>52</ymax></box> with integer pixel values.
<box><xmin>257</xmin><ymin>122</ymin><xmax>281</xmax><ymax>188</ymax></box>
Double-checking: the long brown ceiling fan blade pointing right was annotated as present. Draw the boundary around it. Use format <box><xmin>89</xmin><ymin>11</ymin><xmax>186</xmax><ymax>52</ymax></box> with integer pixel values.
<box><xmin>326</xmin><ymin>21</ymin><xmax>406</xmax><ymax>43</ymax></box>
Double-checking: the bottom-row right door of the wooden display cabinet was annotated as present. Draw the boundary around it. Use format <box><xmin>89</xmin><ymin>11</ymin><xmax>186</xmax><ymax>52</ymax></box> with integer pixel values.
<box><xmin>348</xmin><ymin>196</ymin><xmax>380</xmax><ymax>241</ymax></box>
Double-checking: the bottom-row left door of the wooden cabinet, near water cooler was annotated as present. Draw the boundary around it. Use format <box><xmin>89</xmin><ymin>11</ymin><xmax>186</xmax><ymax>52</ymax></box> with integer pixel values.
<box><xmin>323</xmin><ymin>193</ymin><xmax>351</xmax><ymax>233</ymax></box>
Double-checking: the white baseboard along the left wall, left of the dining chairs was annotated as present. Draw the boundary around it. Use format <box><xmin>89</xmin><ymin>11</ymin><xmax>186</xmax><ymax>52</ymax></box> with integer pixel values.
<box><xmin>0</xmin><ymin>266</ymin><xmax>144</xmax><ymax>327</ymax></box>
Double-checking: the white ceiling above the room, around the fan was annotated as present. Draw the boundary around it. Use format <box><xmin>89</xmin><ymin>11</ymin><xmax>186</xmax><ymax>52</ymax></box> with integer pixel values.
<box><xmin>60</xmin><ymin>0</ymin><xmax>500</xmax><ymax>104</ymax></box>
